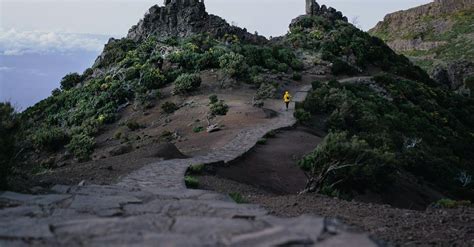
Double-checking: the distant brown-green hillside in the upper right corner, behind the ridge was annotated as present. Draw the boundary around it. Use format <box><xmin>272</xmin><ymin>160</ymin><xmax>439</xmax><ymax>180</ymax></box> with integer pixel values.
<box><xmin>369</xmin><ymin>0</ymin><xmax>474</xmax><ymax>93</ymax></box>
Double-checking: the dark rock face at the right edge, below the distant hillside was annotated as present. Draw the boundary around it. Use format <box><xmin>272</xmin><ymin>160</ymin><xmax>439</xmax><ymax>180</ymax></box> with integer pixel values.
<box><xmin>431</xmin><ymin>60</ymin><xmax>474</xmax><ymax>90</ymax></box>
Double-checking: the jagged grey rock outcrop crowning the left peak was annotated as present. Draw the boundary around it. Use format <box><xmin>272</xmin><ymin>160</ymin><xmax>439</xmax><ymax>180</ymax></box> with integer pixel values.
<box><xmin>127</xmin><ymin>0</ymin><xmax>266</xmax><ymax>43</ymax></box>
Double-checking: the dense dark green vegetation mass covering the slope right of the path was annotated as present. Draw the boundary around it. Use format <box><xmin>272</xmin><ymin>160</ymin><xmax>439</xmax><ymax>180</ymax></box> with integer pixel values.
<box><xmin>300</xmin><ymin>75</ymin><xmax>474</xmax><ymax>199</ymax></box>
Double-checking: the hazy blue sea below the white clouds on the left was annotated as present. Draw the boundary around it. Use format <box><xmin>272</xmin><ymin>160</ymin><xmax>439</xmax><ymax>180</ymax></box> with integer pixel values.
<box><xmin>0</xmin><ymin>51</ymin><xmax>100</xmax><ymax>111</ymax></box>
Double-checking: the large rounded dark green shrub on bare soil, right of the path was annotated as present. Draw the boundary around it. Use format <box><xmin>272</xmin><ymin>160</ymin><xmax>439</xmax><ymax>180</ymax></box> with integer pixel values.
<box><xmin>299</xmin><ymin>132</ymin><xmax>394</xmax><ymax>193</ymax></box>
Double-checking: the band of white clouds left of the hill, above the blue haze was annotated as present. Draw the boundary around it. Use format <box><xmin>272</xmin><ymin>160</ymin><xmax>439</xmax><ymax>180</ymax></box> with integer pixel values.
<box><xmin>0</xmin><ymin>29</ymin><xmax>107</xmax><ymax>56</ymax></box>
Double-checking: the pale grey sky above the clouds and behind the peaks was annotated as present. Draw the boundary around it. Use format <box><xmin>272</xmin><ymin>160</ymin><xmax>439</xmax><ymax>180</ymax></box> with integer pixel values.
<box><xmin>0</xmin><ymin>0</ymin><xmax>430</xmax><ymax>55</ymax></box>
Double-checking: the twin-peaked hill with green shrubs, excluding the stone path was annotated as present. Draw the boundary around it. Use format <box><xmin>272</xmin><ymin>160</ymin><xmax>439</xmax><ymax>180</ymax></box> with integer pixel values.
<box><xmin>1</xmin><ymin>0</ymin><xmax>474</xmax><ymax>209</ymax></box>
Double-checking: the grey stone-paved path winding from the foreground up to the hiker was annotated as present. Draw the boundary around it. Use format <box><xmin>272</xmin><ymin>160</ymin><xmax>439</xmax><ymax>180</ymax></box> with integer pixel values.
<box><xmin>0</xmin><ymin>86</ymin><xmax>375</xmax><ymax>246</ymax></box>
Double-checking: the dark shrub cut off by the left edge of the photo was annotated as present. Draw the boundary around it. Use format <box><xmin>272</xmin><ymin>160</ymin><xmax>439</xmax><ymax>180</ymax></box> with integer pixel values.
<box><xmin>0</xmin><ymin>103</ymin><xmax>19</xmax><ymax>190</ymax></box>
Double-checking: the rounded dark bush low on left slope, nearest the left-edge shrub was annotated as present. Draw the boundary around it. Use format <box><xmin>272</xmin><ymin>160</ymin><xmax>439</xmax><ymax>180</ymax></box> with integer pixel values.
<box><xmin>32</xmin><ymin>126</ymin><xmax>69</xmax><ymax>151</ymax></box>
